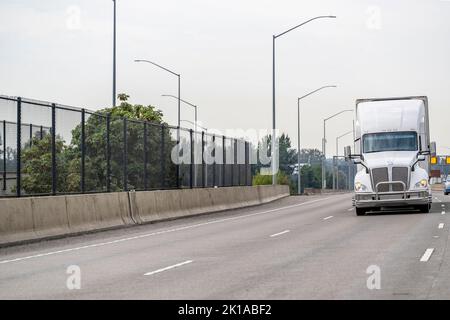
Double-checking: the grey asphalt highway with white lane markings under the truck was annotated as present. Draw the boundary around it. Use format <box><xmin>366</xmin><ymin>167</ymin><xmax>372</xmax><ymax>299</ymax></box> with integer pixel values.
<box><xmin>0</xmin><ymin>192</ymin><xmax>450</xmax><ymax>299</ymax></box>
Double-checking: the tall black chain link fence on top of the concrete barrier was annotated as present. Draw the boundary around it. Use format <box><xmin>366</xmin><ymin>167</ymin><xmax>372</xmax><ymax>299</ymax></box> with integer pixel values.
<box><xmin>0</xmin><ymin>96</ymin><xmax>252</xmax><ymax>197</ymax></box>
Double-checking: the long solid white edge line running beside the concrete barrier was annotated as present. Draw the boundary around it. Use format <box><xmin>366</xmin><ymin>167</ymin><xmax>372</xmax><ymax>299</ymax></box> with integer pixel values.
<box><xmin>0</xmin><ymin>197</ymin><xmax>342</xmax><ymax>265</ymax></box>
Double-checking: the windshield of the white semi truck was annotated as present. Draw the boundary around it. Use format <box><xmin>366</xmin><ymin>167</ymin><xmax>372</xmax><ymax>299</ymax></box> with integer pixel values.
<box><xmin>363</xmin><ymin>132</ymin><xmax>417</xmax><ymax>153</ymax></box>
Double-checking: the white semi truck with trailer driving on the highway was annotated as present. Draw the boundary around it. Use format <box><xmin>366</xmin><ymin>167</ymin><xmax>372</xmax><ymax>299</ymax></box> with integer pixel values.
<box><xmin>345</xmin><ymin>96</ymin><xmax>436</xmax><ymax>215</ymax></box>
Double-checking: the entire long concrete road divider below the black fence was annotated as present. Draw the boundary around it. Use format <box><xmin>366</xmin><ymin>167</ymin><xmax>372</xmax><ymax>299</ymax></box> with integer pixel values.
<box><xmin>0</xmin><ymin>186</ymin><xmax>289</xmax><ymax>246</ymax></box>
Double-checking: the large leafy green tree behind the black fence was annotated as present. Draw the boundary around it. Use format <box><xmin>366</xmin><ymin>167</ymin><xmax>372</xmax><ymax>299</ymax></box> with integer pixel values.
<box><xmin>18</xmin><ymin>94</ymin><xmax>176</xmax><ymax>194</ymax></box>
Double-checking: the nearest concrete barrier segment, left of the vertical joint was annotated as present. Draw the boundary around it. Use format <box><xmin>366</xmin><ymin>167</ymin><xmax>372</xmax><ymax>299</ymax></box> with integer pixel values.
<box><xmin>0</xmin><ymin>192</ymin><xmax>134</xmax><ymax>245</ymax></box>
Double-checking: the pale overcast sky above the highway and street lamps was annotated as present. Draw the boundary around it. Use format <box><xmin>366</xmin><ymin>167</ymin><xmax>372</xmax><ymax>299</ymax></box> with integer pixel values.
<box><xmin>0</xmin><ymin>0</ymin><xmax>450</xmax><ymax>155</ymax></box>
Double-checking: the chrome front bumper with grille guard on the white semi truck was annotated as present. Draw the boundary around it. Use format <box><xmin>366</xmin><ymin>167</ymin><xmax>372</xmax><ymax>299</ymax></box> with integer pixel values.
<box><xmin>353</xmin><ymin>181</ymin><xmax>433</xmax><ymax>208</ymax></box>
